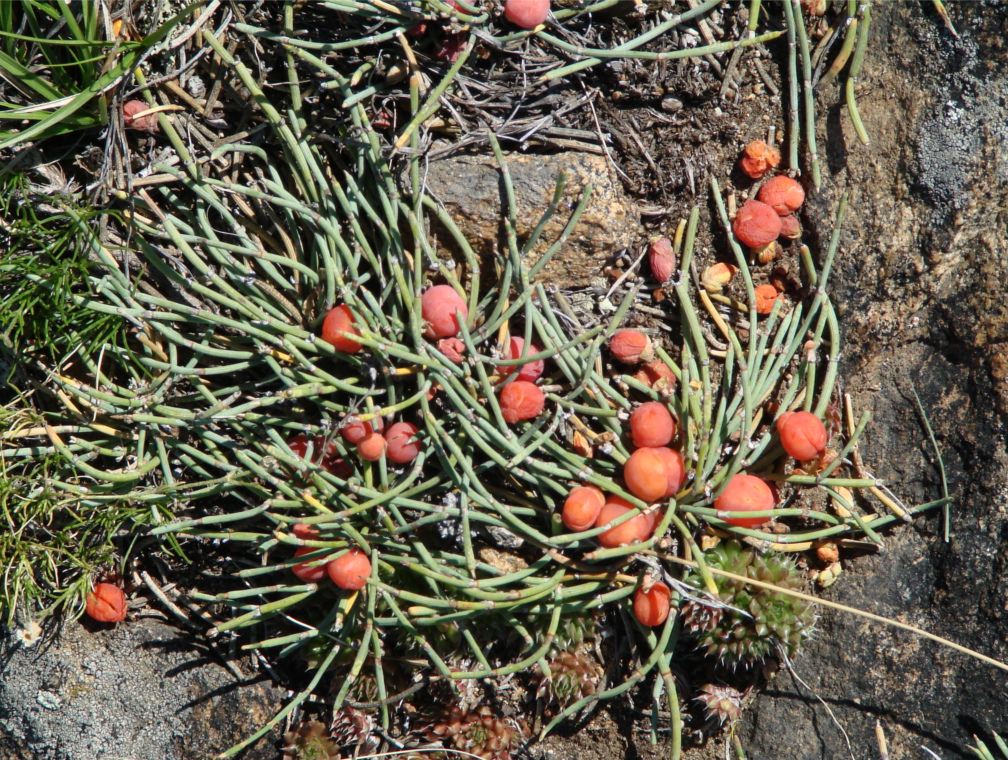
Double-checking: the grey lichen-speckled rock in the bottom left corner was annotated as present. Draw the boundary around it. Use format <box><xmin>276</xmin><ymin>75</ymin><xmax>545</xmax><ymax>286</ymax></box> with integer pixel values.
<box><xmin>0</xmin><ymin>619</ymin><xmax>282</xmax><ymax>760</ymax></box>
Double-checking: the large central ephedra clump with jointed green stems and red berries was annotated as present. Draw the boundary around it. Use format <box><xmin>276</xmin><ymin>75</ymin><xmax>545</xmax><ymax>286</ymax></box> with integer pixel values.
<box><xmin>3</xmin><ymin>1</ymin><xmax>943</xmax><ymax>757</ymax></box>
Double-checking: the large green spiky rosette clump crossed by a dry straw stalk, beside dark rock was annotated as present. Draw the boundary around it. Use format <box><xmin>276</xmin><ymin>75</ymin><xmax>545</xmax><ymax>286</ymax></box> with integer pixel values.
<box><xmin>683</xmin><ymin>540</ymin><xmax>815</xmax><ymax>667</ymax></box>
